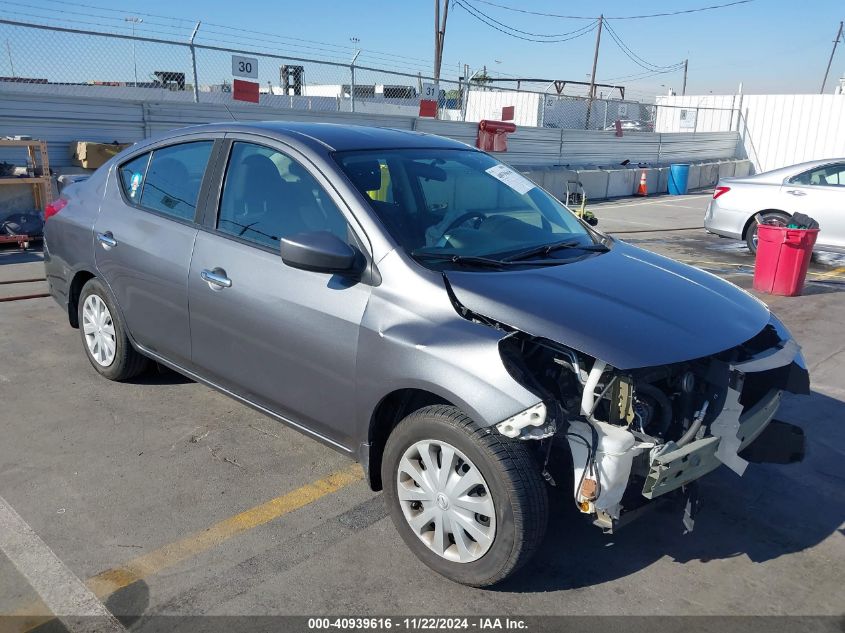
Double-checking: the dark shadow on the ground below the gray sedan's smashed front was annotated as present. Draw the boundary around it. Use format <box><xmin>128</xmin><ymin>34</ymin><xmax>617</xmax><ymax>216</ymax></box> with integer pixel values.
<box><xmin>494</xmin><ymin>392</ymin><xmax>845</xmax><ymax>593</ymax></box>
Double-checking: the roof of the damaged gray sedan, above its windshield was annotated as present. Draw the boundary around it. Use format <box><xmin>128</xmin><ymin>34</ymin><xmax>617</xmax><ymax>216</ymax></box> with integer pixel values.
<box><xmin>160</xmin><ymin>121</ymin><xmax>469</xmax><ymax>152</ymax></box>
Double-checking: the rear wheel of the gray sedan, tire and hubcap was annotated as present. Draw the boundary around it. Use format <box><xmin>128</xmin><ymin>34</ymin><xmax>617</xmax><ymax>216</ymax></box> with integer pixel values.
<box><xmin>77</xmin><ymin>278</ymin><xmax>148</xmax><ymax>381</ymax></box>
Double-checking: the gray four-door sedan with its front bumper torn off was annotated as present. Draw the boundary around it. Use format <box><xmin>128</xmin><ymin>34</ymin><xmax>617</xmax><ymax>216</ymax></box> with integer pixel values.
<box><xmin>45</xmin><ymin>123</ymin><xmax>809</xmax><ymax>586</ymax></box>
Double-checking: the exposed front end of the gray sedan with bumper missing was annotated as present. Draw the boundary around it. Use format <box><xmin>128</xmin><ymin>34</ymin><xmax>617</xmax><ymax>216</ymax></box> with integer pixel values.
<box><xmin>488</xmin><ymin>319</ymin><xmax>809</xmax><ymax>531</ymax></box>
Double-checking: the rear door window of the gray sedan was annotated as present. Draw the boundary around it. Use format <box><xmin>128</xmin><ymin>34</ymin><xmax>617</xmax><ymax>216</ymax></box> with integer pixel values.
<box><xmin>139</xmin><ymin>141</ymin><xmax>213</xmax><ymax>220</ymax></box>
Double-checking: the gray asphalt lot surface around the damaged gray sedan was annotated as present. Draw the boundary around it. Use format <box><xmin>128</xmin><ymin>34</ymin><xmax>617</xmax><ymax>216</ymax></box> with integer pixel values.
<box><xmin>0</xmin><ymin>195</ymin><xmax>845</xmax><ymax>630</ymax></box>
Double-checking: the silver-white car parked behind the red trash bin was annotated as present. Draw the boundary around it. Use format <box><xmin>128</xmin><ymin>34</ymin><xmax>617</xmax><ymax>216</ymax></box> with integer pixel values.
<box><xmin>704</xmin><ymin>158</ymin><xmax>845</xmax><ymax>253</ymax></box>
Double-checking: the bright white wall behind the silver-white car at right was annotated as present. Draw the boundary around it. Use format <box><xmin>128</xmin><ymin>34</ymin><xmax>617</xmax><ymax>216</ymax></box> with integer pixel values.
<box><xmin>655</xmin><ymin>94</ymin><xmax>845</xmax><ymax>172</ymax></box>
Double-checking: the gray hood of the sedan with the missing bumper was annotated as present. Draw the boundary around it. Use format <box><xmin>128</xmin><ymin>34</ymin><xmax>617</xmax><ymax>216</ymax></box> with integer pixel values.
<box><xmin>446</xmin><ymin>241</ymin><xmax>771</xmax><ymax>369</ymax></box>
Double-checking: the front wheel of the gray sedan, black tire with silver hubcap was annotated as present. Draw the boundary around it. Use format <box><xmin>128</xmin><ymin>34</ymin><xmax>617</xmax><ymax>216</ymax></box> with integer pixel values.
<box><xmin>382</xmin><ymin>405</ymin><xmax>548</xmax><ymax>587</ymax></box>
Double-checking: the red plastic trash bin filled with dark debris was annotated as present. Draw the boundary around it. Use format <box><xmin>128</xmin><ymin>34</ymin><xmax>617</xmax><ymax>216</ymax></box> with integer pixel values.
<box><xmin>754</xmin><ymin>224</ymin><xmax>819</xmax><ymax>297</ymax></box>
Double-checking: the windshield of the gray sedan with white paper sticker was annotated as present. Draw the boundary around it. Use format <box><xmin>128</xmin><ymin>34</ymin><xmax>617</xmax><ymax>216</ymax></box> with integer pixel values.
<box><xmin>335</xmin><ymin>149</ymin><xmax>605</xmax><ymax>268</ymax></box>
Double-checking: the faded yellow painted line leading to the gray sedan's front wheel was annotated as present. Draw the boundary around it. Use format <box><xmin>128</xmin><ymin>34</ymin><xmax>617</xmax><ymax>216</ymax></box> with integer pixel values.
<box><xmin>11</xmin><ymin>464</ymin><xmax>364</xmax><ymax>630</ymax></box>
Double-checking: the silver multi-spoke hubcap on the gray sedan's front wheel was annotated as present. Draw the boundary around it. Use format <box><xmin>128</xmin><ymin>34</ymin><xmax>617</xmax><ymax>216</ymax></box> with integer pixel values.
<box><xmin>396</xmin><ymin>440</ymin><xmax>496</xmax><ymax>563</ymax></box>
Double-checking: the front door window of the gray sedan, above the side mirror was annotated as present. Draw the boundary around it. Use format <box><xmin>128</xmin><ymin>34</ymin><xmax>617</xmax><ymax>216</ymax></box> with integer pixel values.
<box><xmin>217</xmin><ymin>143</ymin><xmax>347</xmax><ymax>249</ymax></box>
